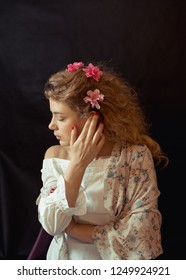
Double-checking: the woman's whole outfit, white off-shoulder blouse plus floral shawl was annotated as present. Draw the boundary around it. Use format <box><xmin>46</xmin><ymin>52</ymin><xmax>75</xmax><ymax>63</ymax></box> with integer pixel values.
<box><xmin>36</xmin><ymin>144</ymin><xmax>163</xmax><ymax>260</ymax></box>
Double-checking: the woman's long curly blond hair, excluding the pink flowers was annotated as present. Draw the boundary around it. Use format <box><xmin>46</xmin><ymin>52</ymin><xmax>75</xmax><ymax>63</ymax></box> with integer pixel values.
<box><xmin>44</xmin><ymin>64</ymin><xmax>168</xmax><ymax>166</ymax></box>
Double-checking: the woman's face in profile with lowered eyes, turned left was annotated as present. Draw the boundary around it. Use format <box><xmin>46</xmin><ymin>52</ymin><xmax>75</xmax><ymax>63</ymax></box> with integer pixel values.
<box><xmin>48</xmin><ymin>98</ymin><xmax>87</xmax><ymax>146</ymax></box>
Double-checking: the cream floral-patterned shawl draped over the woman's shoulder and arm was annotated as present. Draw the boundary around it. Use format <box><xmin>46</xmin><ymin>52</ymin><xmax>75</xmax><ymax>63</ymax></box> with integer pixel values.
<box><xmin>93</xmin><ymin>145</ymin><xmax>162</xmax><ymax>260</ymax></box>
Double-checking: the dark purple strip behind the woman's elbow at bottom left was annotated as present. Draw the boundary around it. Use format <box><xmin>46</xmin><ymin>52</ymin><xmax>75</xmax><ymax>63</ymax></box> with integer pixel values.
<box><xmin>27</xmin><ymin>228</ymin><xmax>53</xmax><ymax>260</ymax></box>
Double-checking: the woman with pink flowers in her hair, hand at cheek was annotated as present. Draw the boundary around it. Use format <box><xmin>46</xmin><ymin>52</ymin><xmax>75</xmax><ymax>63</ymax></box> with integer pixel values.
<box><xmin>37</xmin><ymin>62</ymin><xmax>168</xmax><ymax>260</ymax></box>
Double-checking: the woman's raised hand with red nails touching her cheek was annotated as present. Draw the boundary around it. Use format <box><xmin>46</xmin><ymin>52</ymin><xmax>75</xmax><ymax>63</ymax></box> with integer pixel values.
<box><xmin>70</xmin><ymin>114</ymin><xmax>105</xmax><ymax>167</ymax></box>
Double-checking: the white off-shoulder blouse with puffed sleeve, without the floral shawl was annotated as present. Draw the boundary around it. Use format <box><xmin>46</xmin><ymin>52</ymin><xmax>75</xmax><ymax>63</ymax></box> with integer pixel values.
<box><xmin>37</xmin><ymin>158</ymin><xmax>112</xmax><ymax>259</ymax></box>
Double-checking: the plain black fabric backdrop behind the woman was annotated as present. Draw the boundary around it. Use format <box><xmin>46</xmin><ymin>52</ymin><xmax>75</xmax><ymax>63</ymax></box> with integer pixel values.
<box><xmin>0</xmin><ymin>0</ymin><xmax>186</xmax><ymax>260</ymax></box>
